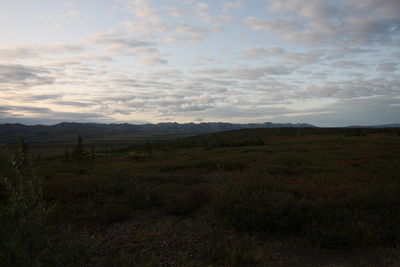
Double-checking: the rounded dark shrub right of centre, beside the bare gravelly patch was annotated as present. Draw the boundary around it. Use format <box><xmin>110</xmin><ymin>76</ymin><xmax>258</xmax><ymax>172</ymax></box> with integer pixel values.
<box><xmin>214</xmin><ymin>176</ymin><xmax>307</xmax><ymax>234</ymax></box>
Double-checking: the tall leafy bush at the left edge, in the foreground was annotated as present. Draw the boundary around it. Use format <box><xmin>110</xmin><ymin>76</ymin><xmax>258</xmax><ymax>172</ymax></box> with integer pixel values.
<box><xmin>0</xmin><ymin>146</ymin><xmax>50</xmax><ymax>266</ymax></box>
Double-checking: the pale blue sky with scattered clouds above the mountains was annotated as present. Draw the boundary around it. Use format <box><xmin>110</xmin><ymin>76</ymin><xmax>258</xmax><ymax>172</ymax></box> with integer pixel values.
<box><xmin>0</xmin><ymin>0</ymin><xmax>400</xmax><ymax>126</ymax></box>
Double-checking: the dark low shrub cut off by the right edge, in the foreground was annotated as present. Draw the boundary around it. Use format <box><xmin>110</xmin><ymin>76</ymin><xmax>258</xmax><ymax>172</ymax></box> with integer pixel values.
<box><xmin>305</xmin><ymin>185</ymin><xmax>400</xmax><ymax>248</ymax></box>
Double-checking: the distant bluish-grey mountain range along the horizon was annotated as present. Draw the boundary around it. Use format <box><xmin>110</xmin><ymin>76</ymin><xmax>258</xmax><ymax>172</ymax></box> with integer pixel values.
<box><xmin>0</xmin><ymin>122</ymin><xmax>316</xmax><ymax>143</ymax></box>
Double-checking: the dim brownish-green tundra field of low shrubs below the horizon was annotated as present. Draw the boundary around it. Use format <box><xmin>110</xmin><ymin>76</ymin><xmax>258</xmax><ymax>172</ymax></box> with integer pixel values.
<box><xmin>2</xmin><ymin>129</ymin><xmax>400</xmax><ymax>266</ymax></box>
